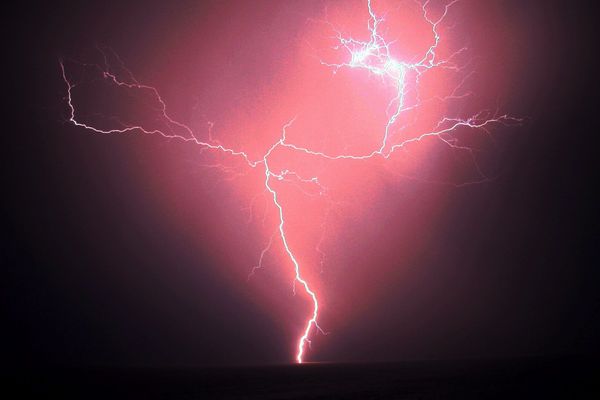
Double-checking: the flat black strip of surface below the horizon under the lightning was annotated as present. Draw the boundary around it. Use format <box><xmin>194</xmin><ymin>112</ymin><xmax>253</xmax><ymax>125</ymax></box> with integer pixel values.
<box><xmin>7</xmin><ymin>358</ymin><xmax>600</xmax><ymax>399</ymax></box>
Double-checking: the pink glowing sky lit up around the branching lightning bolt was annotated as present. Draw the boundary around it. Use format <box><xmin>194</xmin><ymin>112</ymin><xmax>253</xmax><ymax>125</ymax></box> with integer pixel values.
<box><xmin>58</xmin><ymin>0</ymin><xmax>518</xmax><ymax>360</ymax></box>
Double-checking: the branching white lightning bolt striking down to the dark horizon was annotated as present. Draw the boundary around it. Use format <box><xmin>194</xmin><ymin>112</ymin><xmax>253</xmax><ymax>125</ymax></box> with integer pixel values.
<box><xmin>60</xmin><ymin>0</ymin><xmax>521</xmax><ymax>363</ymax></box>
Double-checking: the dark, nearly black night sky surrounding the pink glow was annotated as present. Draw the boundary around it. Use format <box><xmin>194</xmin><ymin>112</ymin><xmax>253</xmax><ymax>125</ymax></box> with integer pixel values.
<box><xmin>0</xmin><ymin>0</ymin><xmax>600</xmax><ymax>366</ymax></box>
